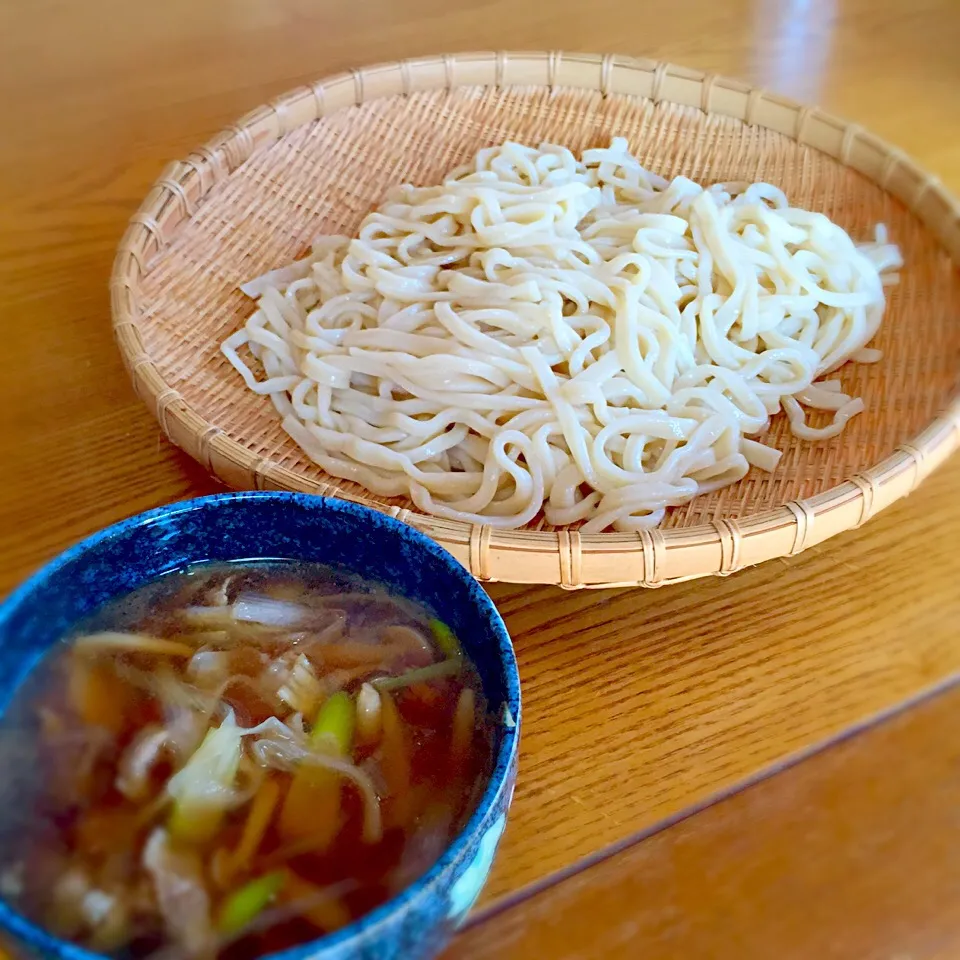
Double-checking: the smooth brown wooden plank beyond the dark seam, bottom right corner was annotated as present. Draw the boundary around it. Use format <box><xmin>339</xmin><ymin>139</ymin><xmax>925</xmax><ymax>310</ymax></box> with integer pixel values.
<box><xmin>444</xmin><ymin>688</ymin><xmax>960</xmax><ymax>960</ymax></box>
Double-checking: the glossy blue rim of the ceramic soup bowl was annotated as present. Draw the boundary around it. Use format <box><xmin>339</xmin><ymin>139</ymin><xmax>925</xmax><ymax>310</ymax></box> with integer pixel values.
<box><xmin>0</xmin><ymin>490</ymin><xmax>522</xmax><ymax>960</ymax></box>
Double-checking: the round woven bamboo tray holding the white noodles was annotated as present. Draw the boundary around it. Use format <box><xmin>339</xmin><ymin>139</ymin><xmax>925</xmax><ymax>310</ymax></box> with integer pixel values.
<box><xmin>111</xmin><ymin>53</ymin><xmax>960</xmax><ymax>588</ymax></box>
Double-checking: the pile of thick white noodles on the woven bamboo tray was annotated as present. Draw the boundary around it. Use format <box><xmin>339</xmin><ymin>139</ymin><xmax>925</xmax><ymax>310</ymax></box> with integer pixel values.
<box><xmin>223</xmin><ymin>138</ymin><xmax>901</xmax><ymax>533</ymax></box>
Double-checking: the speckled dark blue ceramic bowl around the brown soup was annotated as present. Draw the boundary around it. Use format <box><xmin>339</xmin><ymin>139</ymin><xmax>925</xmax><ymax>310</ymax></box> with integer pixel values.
<box><xmin>0</xmin><ymin>492</ymin><xmax>520</xmax><ymax>960</ymax></box>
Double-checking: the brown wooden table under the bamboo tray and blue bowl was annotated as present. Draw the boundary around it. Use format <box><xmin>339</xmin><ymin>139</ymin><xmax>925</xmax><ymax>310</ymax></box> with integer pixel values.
<box><xmin>0</xmin><ymin>0</ymin><xmax>960</xmax><ymax>960</ymax></box>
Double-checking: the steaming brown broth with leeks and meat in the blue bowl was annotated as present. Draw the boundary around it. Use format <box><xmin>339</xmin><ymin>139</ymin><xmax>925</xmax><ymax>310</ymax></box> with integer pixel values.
<box><xmin>0</xmin><ymin>561</ymin><xmax>492</xmax><ymax>960</ymax></box>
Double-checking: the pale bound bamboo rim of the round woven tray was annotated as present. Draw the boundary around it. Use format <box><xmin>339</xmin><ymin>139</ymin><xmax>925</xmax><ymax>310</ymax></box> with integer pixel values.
<box><xmin>110</xmin><ymin>51</ymin><xmax>960</xmax><ymax>589</ymax></box>
